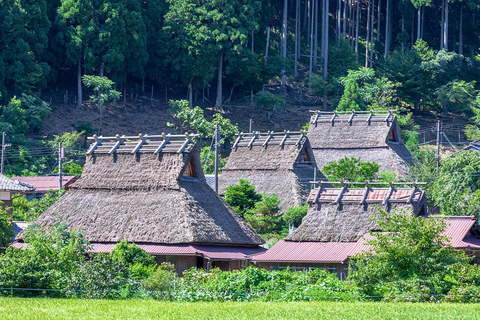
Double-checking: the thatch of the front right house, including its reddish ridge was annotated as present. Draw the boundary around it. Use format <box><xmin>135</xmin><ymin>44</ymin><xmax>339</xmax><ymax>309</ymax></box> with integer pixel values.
<box><xmin>285</xmin><ymin>187</ymin><xmax>426</xmax><ymax>242</ymax></box>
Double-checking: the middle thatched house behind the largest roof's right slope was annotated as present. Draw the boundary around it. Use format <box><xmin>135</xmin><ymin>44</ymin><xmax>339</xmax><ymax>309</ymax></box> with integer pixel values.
<box><xmin>219</xmin><ymin>131</ymin><xmax>321</xmax><ymax>212</ymax></box>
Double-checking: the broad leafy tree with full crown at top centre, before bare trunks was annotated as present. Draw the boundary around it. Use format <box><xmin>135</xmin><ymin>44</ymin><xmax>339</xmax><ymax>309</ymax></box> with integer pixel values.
<box><xmin>164</xmin><ymin>0</ymin><xmax>261</xmax><ymax>107</ymax></box>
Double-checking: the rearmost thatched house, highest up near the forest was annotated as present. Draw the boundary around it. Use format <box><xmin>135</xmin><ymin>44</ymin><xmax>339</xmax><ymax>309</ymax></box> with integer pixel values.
<box><xmin>308</xmin><ymin>111</ymin><xmax>413</xmax><ymax>177</ymax></box>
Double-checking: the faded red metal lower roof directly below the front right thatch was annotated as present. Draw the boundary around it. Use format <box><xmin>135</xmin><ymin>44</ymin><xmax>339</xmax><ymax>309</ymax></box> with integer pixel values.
<box><xmin>249</xmin><ymin>240</ymin><xmax>355</xmax><ymax>263</ymax></box>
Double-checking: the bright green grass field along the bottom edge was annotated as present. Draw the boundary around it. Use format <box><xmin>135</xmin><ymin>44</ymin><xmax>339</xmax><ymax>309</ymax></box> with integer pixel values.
<box><xmin>0</xmin><ymin>298</ymin><xmax>480</xmax><ymax>320</ymax></box>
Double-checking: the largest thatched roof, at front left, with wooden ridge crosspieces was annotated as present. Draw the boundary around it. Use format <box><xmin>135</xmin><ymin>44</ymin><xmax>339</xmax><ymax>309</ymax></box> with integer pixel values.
<box><xmin>27</xmin><ymin>136</ymin><xmax>263</xmax><ymax>245</ymax></box>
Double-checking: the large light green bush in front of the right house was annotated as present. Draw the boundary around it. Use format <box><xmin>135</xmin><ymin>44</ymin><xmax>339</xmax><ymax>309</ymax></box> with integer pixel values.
<box><xmin>349</xmin><ymin>210</ymin><xmax>470</xmax><ymax>296</ymax></box>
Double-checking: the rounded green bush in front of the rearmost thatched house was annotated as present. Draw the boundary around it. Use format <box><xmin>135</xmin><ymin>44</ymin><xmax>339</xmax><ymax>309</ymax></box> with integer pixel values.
<box><xmin>323</xmin><ymin>157</ymin><xmax>380</xmax><ymax>182</ymax></box>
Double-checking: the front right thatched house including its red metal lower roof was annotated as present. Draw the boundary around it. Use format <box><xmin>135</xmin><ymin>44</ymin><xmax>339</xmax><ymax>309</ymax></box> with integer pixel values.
<box><xmin>251</xmin><ymin>185</ymin><xmax>427</xmax><ymax>278</ymax></box>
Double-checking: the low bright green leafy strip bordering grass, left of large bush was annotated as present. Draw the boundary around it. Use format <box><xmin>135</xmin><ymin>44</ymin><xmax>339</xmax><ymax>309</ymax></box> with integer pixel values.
<box><xmin>176</xmin><ymin>267</ymin><xmax>359</xmax><ymax>301</ymax></box>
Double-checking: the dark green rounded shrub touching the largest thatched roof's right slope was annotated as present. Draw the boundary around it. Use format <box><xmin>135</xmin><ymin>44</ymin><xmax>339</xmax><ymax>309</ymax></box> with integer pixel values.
<box><xmin>225</xmin><ymin>179</ymin><xmax>262</xmax><ymax>217</ymax></box>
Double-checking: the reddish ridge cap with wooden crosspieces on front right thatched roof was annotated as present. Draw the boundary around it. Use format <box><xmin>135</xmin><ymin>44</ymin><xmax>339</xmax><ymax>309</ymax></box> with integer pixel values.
<box><xmin>308</xmin><ymin>188</ymin><xmax>424</xmax><ymax>203</ymax></box>
